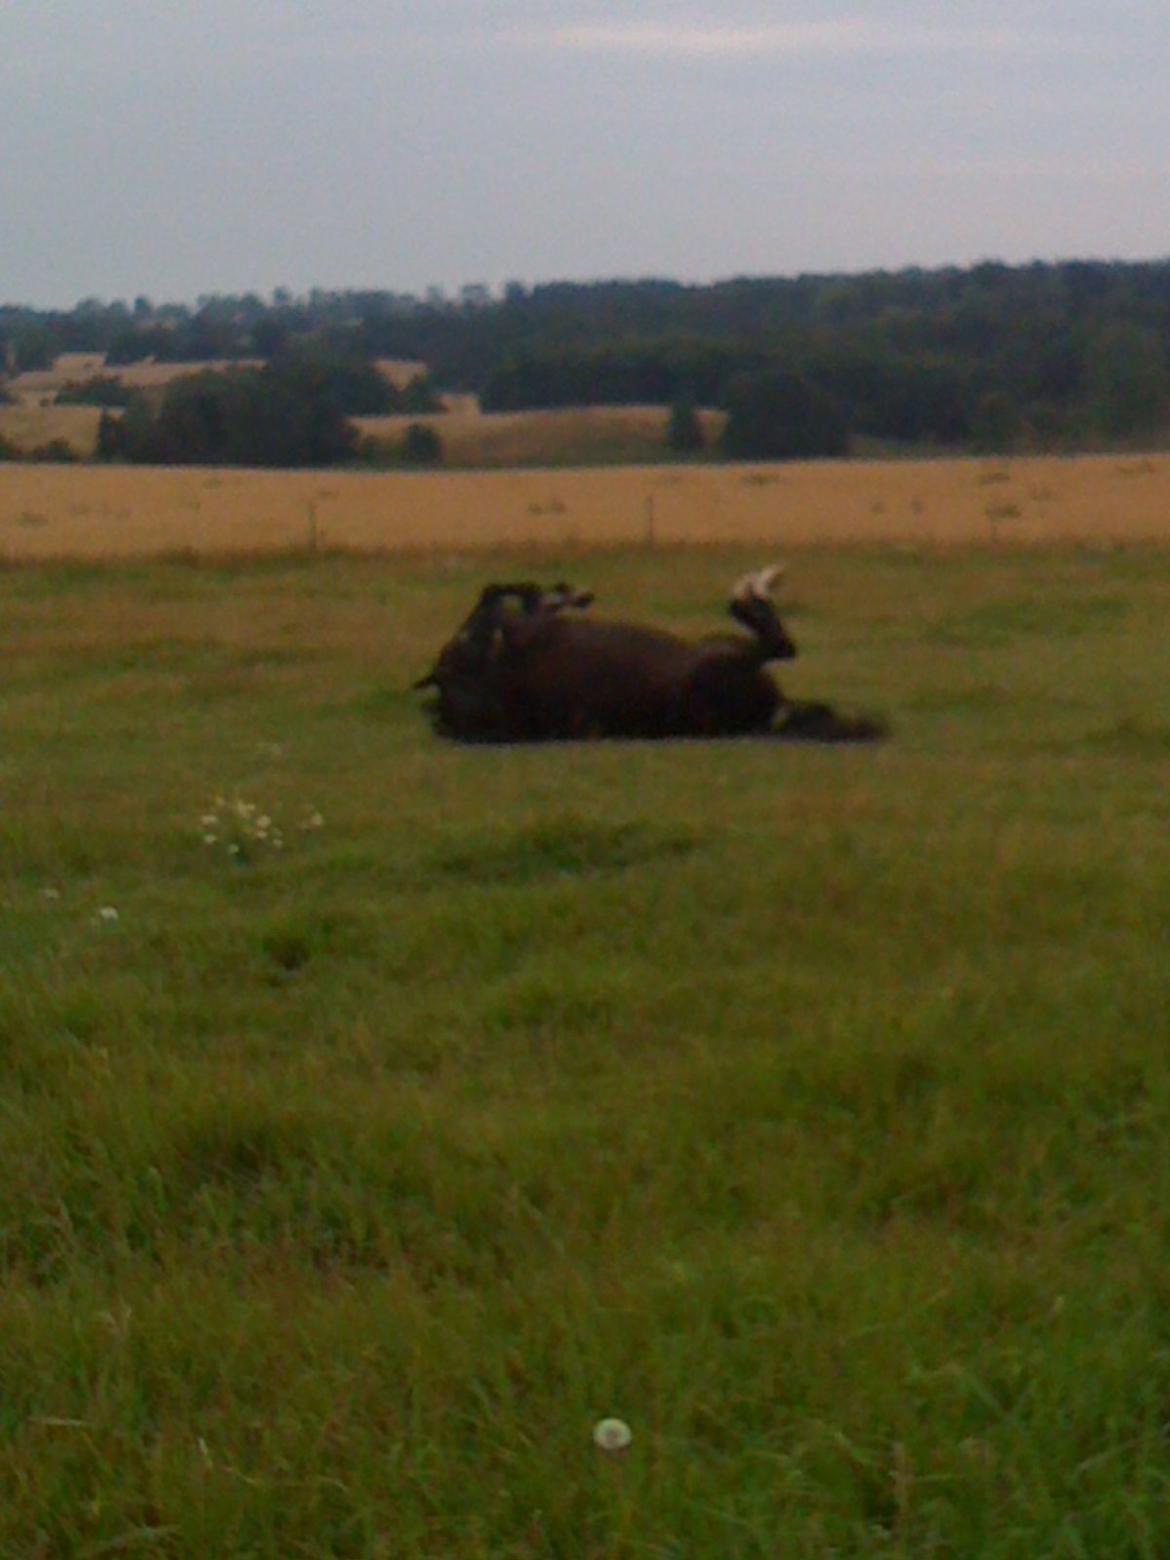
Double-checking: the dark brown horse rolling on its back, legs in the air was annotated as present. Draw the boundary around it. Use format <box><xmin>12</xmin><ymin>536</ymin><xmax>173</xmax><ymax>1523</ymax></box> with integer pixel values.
<box><xmin>415</xmin><ymin>568</ymin><xmax>885</xmax><ymax>743</ymax></box>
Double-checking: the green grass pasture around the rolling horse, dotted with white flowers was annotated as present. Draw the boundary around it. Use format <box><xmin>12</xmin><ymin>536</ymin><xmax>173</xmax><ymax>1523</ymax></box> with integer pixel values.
<box><xmin>0</xmin><ymin>551</ymin><xmax>1170</xmax><ymax>1560</ymax></box>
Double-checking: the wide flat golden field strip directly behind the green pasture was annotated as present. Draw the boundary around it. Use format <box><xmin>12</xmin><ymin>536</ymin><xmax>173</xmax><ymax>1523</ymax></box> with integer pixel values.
<box><xmin>0</xmin><ymin>456</ymin><xmax>1170</xmax><ymax>562</ymax></box>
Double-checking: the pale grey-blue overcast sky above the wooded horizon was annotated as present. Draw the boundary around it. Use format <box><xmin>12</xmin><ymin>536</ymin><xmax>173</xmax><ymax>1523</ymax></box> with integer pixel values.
<box><xmin>0</xmin><ymin>0</ymin><xmax>1170</xmax><ymax>306</ymax></box>
